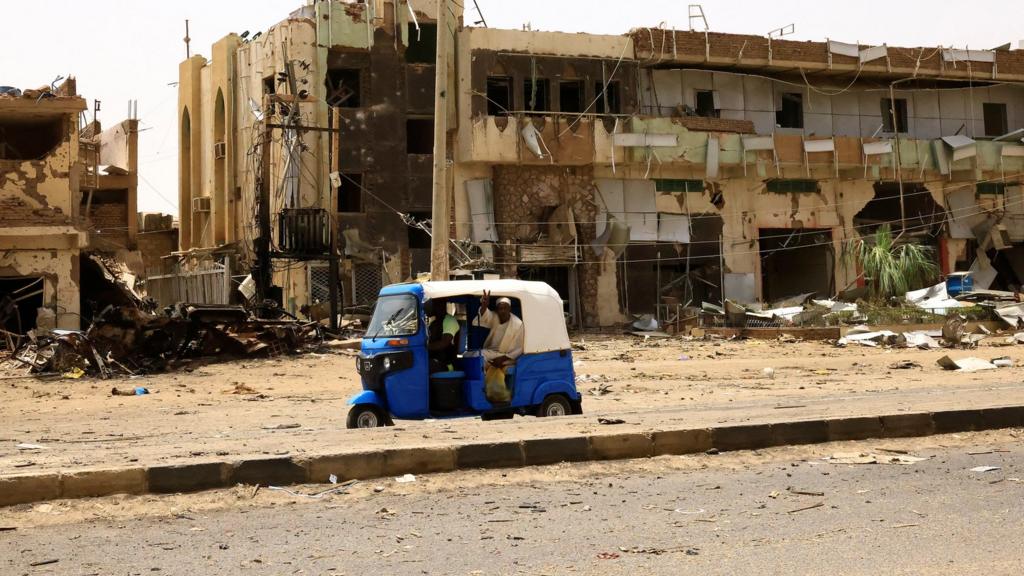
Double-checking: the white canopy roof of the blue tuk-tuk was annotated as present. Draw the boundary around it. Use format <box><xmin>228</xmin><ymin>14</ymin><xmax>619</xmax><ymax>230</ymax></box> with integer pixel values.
<box><xmin>422</xmin><ymin>280</ymin><xmax>570</xmax><ymax>354</ymax></box>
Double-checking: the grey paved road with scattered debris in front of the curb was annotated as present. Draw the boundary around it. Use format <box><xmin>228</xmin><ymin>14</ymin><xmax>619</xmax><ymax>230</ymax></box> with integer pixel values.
<box><xmin>0</xmin><ymin>431</ymin><xmax>1024</xmax><ymax>576</ymax></box>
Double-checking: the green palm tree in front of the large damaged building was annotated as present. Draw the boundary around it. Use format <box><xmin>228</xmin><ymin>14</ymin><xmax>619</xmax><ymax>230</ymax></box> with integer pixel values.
<box><xmin>851</xmin><ymin>224</ymin><xmax>939</xmax><ymax>301</ymax></box>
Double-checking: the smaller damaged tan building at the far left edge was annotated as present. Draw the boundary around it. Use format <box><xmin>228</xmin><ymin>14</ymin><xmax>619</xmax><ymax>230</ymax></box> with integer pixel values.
<box><xmin>0</xmin><ymin>78</ymin><xmax>165</xmax><ymax>336</ymax></box>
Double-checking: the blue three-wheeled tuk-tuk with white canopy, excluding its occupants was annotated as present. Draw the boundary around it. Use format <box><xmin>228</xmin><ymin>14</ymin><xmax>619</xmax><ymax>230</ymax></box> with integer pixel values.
<box><xmin>347</xmin><ymin>280</ymin><xmax>583</xmax><ymax>428</ymax></box>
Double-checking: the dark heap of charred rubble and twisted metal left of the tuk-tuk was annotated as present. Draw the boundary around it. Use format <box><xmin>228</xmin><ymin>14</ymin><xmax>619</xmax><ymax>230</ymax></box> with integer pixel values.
<box><xmin>13</xmin><ymin>304</ymin><xmax>323</xmax><ymax>378</ymax></box>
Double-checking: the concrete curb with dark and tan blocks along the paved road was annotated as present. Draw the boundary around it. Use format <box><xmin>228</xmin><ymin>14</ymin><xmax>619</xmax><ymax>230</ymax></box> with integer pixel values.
<box><xmin>6</xmin><ymin>406</ymin><xmax>1024</xmax><ymax>506</ymax></box>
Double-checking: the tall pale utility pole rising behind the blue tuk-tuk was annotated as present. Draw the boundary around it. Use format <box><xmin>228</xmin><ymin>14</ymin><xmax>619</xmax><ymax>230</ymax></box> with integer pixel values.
<box><xmin>430</xmin><ymin>0</ymin><xmax>451</xmax><ymax>280</ymax></box>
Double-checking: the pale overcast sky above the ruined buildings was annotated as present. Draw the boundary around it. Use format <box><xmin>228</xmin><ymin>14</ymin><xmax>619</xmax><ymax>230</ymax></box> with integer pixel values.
<box><xmin>0</xmin><ymin>0</ymin><xmax>1024</xmax><ymax>213</ymax></box>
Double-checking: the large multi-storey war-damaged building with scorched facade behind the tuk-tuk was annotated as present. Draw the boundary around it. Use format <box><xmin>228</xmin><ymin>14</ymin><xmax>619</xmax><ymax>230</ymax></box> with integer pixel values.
<box><xmin>179</xmin><ymin>0</ymin><xmax>1024</xmax><ymax>326</ymax></box>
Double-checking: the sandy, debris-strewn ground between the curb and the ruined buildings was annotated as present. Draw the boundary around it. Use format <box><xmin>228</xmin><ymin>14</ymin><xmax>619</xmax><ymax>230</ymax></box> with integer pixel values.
<box><xmin>0</xmin><ymin>335</ymin><xmax>1024</xmax><ymax>475</ymax></box>
